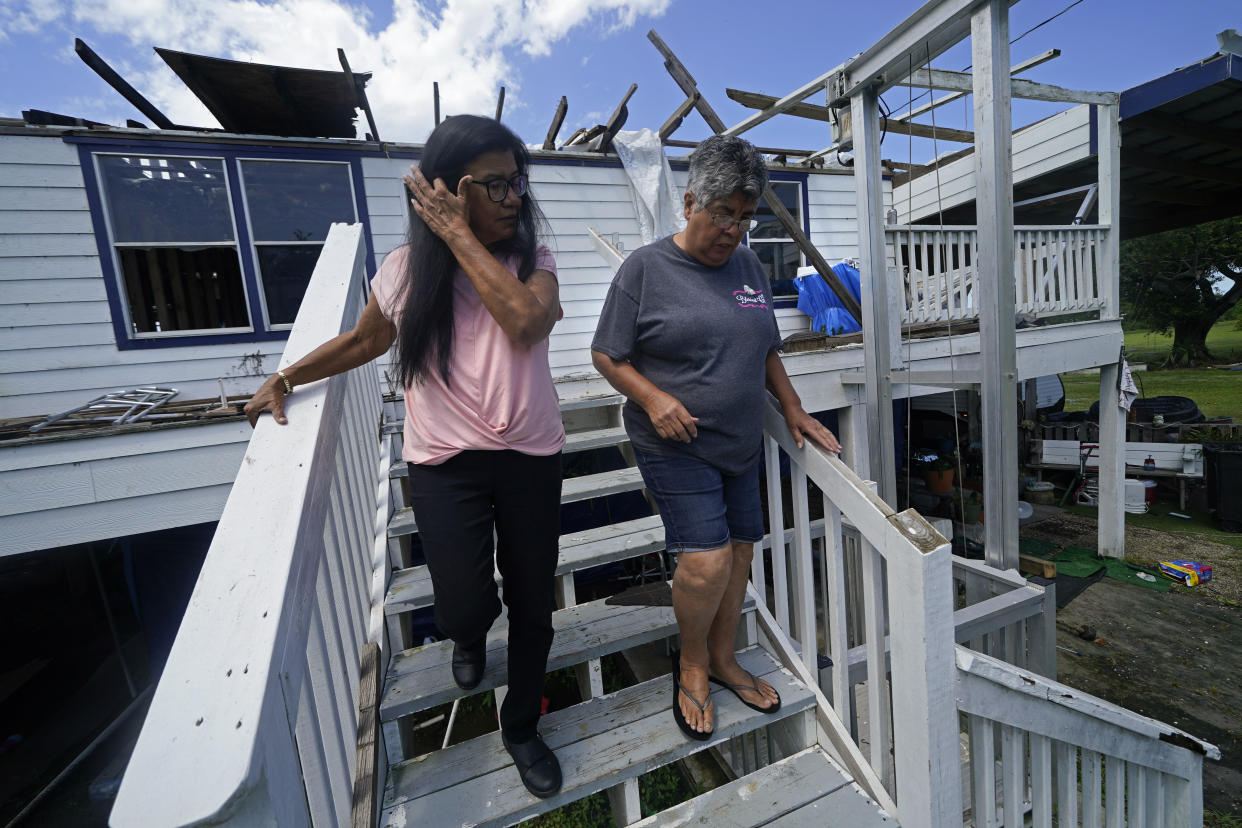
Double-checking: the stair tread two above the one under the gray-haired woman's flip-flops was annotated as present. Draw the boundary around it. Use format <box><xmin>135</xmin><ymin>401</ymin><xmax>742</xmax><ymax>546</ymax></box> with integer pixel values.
<box><xmin>384</xmin><ymin>515</ymin><xmax>664</xmax><ymax>616</ymax></box>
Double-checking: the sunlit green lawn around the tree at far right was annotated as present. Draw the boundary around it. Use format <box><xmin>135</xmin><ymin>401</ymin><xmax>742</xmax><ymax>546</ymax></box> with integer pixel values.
<box><xmin>1061</xmin><ymin>322</ymin><xmax>1242</xmax><ymax>421</ymax></box>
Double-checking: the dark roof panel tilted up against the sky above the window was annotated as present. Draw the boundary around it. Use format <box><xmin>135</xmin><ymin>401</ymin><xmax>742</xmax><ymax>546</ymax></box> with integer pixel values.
<box><xmin>155</xmin><ymin>48</ymin><xmax>371</xmax><ymax>138</ymax></box>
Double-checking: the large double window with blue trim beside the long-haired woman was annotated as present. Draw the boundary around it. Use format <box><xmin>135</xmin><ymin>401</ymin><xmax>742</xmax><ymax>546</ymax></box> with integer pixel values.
<box><xmin>93</xmin><ymin>153</ymin><xmax>356</xmax><ymax>344</ymax></box>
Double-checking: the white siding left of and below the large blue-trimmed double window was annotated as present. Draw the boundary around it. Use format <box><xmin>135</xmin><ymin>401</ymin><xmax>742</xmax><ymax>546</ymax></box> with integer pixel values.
<box><xmin>0</xmin><ymin>135</ymin><xmax>284</xmax><ymax>418</ymax></box>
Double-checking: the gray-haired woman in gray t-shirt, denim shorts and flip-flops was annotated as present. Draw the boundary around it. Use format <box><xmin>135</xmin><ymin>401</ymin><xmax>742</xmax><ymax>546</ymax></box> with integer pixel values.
<box><xmin>591</xmin><ymin>135</ymin><xmax>841</xmax><ymax>741</ymax></box>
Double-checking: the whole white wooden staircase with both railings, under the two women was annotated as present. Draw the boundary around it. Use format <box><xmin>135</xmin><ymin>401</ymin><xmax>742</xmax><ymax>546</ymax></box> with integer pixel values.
<box><xmin>111</xmin><ymin>225</ymin><xmax>1220</xmax><ymax>828</ymax></box>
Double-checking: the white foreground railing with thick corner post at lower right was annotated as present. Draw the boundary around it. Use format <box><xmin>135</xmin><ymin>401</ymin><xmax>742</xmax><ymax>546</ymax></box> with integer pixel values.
<box><xmin>751</xmin><ymin>400</ymin><xmax>1220</xmax><ymax>828</ymax></box>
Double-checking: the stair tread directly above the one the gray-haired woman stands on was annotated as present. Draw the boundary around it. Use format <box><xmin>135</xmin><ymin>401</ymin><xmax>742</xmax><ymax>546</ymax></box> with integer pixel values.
<box><xmin>380</xmin><ymin>597</ymin><xmax>754</xmax><ymax>721</ymax></box>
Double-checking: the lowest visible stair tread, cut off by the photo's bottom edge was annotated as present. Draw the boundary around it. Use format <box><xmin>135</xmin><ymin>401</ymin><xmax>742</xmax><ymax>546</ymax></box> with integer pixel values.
<box><xmin>631</xmin><ymin>747</ymin><xmax>897</xmax><ymax>828</ymax></box>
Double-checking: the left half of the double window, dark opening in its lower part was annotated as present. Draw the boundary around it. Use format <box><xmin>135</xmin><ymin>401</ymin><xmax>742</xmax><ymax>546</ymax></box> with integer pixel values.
<box><xmin>96</xmin><ymin>155</ymin><xmax>251</xmax><ymax>335</ymax></box>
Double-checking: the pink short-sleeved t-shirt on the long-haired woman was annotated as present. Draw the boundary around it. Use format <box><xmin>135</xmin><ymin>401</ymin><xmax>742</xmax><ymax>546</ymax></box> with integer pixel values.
<box><xmin>371</xmin><ymin>245</ymin><xmax>565</xmax><ymax>466</ymax></box>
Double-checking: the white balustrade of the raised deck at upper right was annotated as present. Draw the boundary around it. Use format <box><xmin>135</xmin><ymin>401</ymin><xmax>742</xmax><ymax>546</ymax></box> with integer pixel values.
<box><xmin>884</xmin><ymin>225</ymin><xmax>1110</xmax><ymax>324</ymax></box>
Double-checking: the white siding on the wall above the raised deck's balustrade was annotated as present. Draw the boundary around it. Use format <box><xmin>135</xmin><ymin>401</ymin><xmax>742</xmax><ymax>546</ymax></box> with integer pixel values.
<box><xmin>893</xmin><ymin>106</ymin><xmax>1090</xmax><ymax>223</ymax></box>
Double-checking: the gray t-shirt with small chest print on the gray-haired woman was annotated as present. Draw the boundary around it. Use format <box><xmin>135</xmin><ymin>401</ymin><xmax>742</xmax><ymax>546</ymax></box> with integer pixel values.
<box><xmin>591</xmin><ymin>236</ymin><xmax>781</xmax><ymax>474</ymax></box>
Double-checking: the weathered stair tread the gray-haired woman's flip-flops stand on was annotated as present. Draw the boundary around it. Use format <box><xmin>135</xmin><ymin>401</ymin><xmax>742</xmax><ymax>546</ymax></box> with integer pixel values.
<box><xmin>380</xmin><ymin>647</ymin><xmax>819</xmax><ymax>828</ymax></box>
